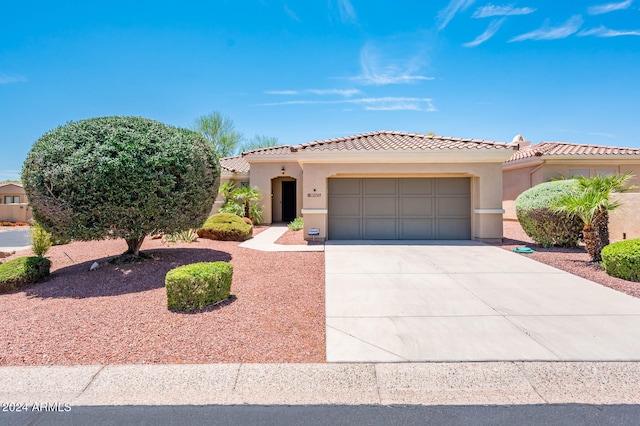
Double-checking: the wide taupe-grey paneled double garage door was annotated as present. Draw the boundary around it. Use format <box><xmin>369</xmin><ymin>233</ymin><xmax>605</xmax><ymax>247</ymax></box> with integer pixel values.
<box><xmin>328</xmin><ymin>178</ymin><xmax>471</xmax><ymax>240</ymax></box>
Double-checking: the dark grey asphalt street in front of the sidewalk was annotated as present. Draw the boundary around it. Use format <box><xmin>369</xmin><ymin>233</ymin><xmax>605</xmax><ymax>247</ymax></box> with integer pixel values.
<box><xmin>0</xmin><ymin>404</ymin><xmax>640</xmax><ymax>426</ymax></box>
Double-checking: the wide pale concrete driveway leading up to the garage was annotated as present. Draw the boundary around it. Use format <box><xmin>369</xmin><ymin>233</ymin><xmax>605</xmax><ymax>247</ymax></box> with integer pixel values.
<box><xmin>325</xmin><ymin>241</ymin><xmax>640</xmax><ymax>362</ymax></box>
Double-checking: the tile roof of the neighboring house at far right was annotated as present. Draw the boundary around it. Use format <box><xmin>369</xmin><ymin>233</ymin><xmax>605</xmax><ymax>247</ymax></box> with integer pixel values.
<box><xmin>505</xmin><ymin>142</ymin><xmax>640</xmax><ymax>163</ymax></box>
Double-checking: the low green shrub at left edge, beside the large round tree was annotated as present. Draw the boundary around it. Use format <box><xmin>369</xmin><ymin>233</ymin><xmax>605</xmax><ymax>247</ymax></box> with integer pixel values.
<box><xmin>0</xmin><ymin>256</ymin><xmax>51</xmax><ymax>293</ymax></box>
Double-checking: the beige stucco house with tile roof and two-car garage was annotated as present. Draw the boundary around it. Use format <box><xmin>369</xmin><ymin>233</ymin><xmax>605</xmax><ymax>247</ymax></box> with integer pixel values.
<box><xmin>218</xmin><ymin>131</ymin><xmax>517</xmax><ymax>241</ymax></box>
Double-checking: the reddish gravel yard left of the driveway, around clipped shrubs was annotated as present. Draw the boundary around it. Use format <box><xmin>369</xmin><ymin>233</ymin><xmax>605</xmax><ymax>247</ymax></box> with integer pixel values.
<box><xmin>0</xmin><ymin>233</ymin><xmax>325</xmax><ymax>365</ymax></box>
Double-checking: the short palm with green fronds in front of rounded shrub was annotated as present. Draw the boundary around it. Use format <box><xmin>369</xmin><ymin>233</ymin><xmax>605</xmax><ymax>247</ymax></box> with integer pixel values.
<box><xmin>553</xmin><ymin>186</ymin><xmax>620</xmax><ymax>262</ymax></box>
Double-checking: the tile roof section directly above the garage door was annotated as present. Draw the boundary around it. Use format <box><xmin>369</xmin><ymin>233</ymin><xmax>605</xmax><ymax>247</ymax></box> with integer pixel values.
<box><xmin>297</xmin><ymin>130</ymin><xmax>514</xmax><ymax>151</ymax></box>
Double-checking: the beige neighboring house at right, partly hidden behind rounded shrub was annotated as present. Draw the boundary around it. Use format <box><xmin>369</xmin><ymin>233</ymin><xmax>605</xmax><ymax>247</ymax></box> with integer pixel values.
<box><xmin>502</xmin><ymin>135</ymin><xmax>640</xmax><ymax>241</ymax></box>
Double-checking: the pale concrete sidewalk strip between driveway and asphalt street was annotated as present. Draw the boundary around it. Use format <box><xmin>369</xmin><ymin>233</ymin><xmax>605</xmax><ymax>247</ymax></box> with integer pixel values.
<box><xmin>0</xmin><ymin>362</ymin><xmax>640</xmax><ymax>407</ymax></box>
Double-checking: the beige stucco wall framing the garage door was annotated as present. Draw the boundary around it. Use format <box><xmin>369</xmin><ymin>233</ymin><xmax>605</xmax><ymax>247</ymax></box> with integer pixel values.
<box><xmin>296</xmin><ymin>163</ymin><xmax>502</xmax><ymax>241</ymax></box>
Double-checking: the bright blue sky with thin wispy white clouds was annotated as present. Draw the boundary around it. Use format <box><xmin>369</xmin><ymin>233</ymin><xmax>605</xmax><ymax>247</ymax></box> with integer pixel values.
<box><xmin>0</xmin><ymin>0</ymin><xmax>640</xmax><ymax>180</ymax></box>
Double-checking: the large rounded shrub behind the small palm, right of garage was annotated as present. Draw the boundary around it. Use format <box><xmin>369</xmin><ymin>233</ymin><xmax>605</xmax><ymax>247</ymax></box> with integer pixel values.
<box><xmin>516</xmin><ymin>179</ymin><xmax>583</xmax><ymax>247</ymax></box>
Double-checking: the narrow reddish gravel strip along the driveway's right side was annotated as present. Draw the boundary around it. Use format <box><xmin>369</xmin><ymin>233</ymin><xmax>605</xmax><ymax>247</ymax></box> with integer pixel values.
<box><xmin>494</xmin><ymin>221</ymin><xmax>640</xmax><ymax>297</ymax></box>
